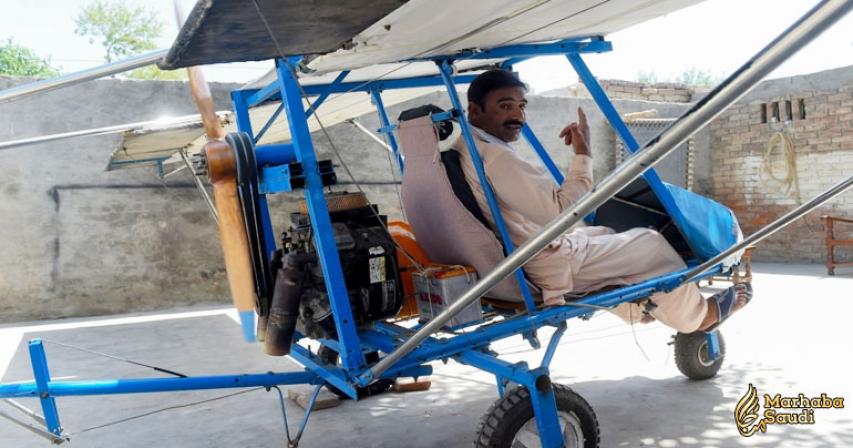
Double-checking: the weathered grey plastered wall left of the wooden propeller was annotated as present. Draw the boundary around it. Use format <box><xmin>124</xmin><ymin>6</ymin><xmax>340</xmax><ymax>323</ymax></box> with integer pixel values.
<box><xmin>0</xmin><ymin>78</ymin><xmax>240</xmax><ymax>321</ymax></box>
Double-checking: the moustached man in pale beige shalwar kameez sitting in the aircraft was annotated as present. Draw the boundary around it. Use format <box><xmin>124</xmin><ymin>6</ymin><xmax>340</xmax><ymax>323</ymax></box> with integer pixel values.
<box><xmin>452</xmin><ymin>70</ymin><xmax>752</xmax><ymax>333</ymax></box>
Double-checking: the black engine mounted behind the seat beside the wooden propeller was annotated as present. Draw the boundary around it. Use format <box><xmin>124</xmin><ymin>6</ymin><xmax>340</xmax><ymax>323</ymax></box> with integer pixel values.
<box><xmin>281</xmin><ymin>193</ymin><xmax>403</xmax><ymax>338</ymax></box>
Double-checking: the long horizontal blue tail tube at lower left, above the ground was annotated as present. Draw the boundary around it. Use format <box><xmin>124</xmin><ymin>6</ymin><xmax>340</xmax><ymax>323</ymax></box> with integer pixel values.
<box><xmin>0</xmin><ymin>371</ymin><xmax>319</xmax><ymax>398</ymax></box>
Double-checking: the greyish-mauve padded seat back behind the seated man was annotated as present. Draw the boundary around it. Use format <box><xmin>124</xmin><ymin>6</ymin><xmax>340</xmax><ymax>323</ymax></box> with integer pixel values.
<box><xmin>398</xmin><ymin>116</ymin><xmax>522</xmax><ymax>301</ymax></box>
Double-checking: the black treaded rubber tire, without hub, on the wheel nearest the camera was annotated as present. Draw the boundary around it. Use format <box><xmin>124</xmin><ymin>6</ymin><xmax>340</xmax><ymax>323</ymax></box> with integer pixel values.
<box><xmin>474</xmin><ymin>384</ymin><xmax>601</xmax><ymax>448</ymax></box>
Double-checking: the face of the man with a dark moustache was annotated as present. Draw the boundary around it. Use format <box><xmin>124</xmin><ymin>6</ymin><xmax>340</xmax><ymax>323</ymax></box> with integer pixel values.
<box><xmin>468</xmin><ymin>87</ymin><xmax>527</xmax><ymax>142</ymax></box>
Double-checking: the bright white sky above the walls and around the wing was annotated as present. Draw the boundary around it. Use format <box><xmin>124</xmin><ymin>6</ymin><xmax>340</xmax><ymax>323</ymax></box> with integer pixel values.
<box><xmin>0</xmin><ymin>0</ymin><xmax>853</xmax><ymax>92</ymax></box>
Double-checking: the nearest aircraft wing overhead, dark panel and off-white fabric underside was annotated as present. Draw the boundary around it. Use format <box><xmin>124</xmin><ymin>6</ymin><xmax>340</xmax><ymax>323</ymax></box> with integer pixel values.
<box><xmin>160</xmin><ymin>0</ymin><xmax>702</xmax><ymax>73</ymax></box>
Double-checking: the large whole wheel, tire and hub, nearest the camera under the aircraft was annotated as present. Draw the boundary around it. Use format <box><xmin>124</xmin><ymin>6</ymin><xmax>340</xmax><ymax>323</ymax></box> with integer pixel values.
<box><xmin>474</xmin><ymin>384</ymin><xmax>599</xmax><ymax>448</ymax></box>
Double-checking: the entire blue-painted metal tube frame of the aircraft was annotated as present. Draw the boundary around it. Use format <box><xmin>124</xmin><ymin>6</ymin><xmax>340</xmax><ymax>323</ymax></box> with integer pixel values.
<box><xmin>0</xmin><ymin>38</ymin><xmax>732</xmax><ymax>447</ymax></box>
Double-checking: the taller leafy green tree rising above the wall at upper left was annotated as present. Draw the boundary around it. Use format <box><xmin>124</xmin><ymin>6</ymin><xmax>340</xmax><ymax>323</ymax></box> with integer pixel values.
<box><xmin>74</xmin><ymin>0</ymin><xmax>163</xmax><ymax>62</ymax></box>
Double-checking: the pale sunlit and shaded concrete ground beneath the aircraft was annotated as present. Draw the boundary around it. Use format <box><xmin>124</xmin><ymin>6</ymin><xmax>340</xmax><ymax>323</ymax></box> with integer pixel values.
<box><xmin>0</xmin><ymin>264</ymin><xmax>853</xmax><ymax>448</ymax></box>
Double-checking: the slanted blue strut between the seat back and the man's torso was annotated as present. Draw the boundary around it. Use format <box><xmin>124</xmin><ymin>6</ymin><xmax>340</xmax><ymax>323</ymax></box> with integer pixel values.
<box><xmin>438</xmin><ymin>60</ymin><xmax>536</xmax><ymax>312</ymax></box>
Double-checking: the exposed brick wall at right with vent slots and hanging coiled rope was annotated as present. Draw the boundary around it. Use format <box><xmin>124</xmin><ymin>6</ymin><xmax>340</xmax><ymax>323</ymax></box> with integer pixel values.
<box><xmin>710</xmin><ymin>67</ymin><xmax>853</xmax><ymax>263</ymax></box>
